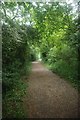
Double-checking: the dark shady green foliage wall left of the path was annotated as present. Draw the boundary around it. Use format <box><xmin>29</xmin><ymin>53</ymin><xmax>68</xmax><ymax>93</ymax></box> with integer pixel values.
<box><xmin>2</xmin><ymin>2</ymin><xmax>37</xmax><ymax>118</ymax></box>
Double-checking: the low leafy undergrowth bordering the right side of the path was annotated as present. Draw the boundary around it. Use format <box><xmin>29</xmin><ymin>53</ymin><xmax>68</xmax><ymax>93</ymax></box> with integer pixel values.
<box><xmin>43</xmin><ymin>61</ymin><xmax>80</xmax><ymax>91</ymax></box>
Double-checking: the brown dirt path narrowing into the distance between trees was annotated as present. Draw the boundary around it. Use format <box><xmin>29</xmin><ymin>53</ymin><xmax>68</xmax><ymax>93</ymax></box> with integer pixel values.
<box><xmin>24</xmin><ymin>62</ymin><xmax>78</xmax><ymax>118</ymax></box>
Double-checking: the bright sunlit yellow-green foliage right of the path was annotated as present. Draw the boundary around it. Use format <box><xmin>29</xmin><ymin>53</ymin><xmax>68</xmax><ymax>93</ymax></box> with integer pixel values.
<box><xmin>31</xmin><ymin>2</ymin><xmax>78</xmax><ymax>87</ymax></box>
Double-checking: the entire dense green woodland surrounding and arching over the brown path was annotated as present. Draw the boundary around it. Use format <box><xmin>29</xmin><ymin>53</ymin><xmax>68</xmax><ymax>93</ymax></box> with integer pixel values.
<box><xmin>1</xmin><ymin>2</ymin><xmax>79</xmax><ymax>117</ymax></box>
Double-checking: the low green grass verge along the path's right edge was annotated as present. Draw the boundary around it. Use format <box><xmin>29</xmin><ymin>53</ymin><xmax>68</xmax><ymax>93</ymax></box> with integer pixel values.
<box><xmin>42</xmin><ymin>62</ymin><xmax>80</xmax><ymax>91</ymax></box>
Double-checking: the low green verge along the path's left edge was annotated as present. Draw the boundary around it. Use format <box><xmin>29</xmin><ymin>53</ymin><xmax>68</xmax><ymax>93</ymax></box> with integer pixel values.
<box><xmin>2</xmin><ymin>63</ymin><xmax>31</xmax><ymax>118</ymax></box>
